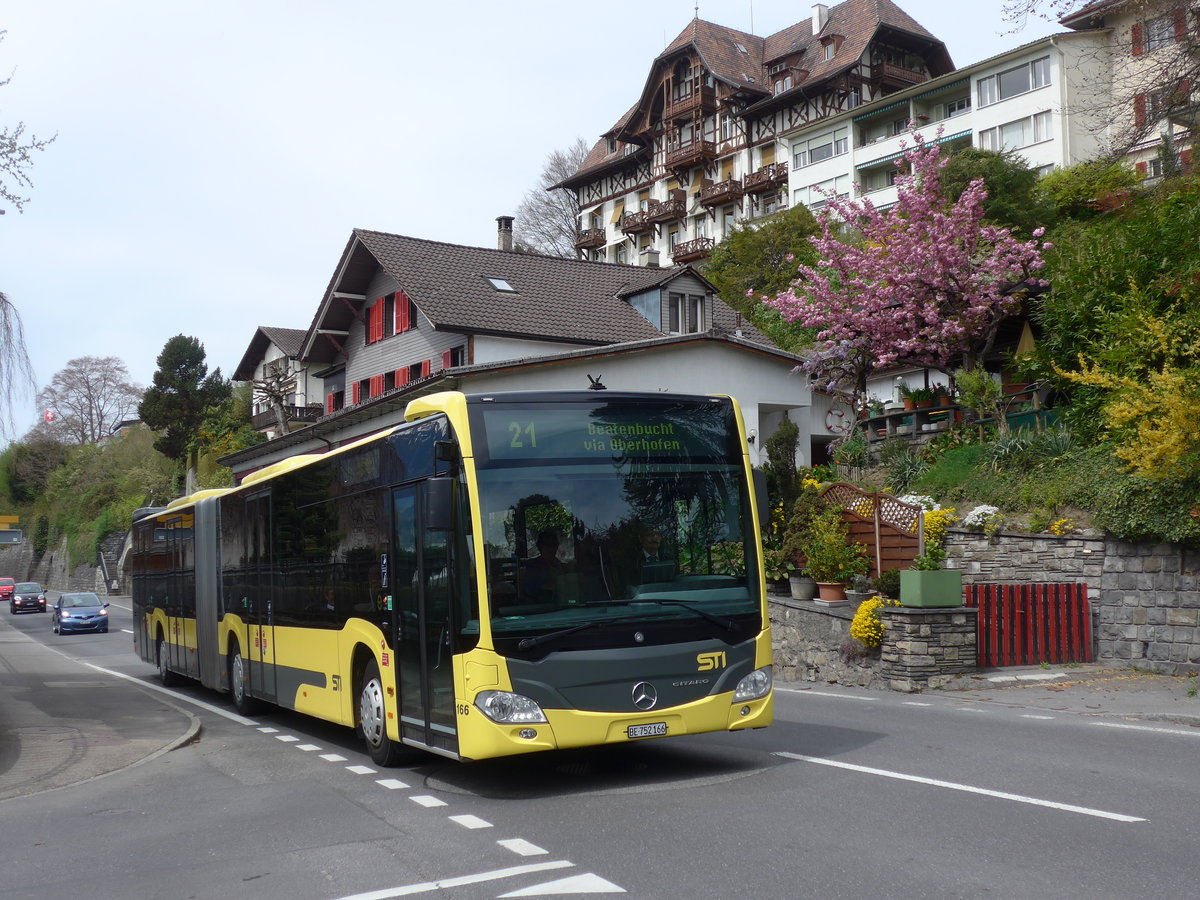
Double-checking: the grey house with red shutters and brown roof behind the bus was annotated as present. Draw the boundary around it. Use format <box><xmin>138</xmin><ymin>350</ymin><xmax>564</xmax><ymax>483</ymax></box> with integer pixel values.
<box><xmin>223</xmin><ymin>223</ymin><xmax>823</xmax><ymax>475</ymax></box>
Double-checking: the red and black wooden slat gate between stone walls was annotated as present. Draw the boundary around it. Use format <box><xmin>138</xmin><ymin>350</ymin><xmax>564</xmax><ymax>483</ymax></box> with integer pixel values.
<box><xmin>962</xmin><ymin>584</ymin><xmax>1092</xmax><ymax>668</ymax></box>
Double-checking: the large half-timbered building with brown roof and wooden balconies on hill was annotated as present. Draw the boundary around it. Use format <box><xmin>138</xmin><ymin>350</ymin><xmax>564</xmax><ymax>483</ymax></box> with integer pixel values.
<box><xmin>562</xmin><ymin>0</ymin><xmax>954</xmax><ymax>264</ymax></box>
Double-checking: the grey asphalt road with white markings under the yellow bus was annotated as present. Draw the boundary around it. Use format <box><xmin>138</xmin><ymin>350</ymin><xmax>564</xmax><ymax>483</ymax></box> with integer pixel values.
<box><xmin>0</xmin><ymin>601</ymin><xmax>1200</xmax><ymax>900</ymax></box>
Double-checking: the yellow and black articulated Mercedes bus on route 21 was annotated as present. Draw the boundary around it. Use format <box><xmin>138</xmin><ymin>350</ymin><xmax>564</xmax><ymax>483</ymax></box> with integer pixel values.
<box><xmin>132</xmin><ymin>391</ymin><xmax>773</xmax><ymax>766</ymax></box>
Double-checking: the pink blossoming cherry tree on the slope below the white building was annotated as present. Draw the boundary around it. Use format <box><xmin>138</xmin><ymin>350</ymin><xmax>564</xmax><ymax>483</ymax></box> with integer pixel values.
<box><xmin>762</xmin><ymin>134</ymin><xmax>1050</xmax><ymax>402</ymax></box>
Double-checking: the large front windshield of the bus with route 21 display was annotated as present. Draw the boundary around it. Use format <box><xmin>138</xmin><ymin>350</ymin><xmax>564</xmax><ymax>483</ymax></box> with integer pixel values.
<box><xmin>475</xmin><ymin>398</ymin><xmax>762</xmax><ymax>656</ymax></box>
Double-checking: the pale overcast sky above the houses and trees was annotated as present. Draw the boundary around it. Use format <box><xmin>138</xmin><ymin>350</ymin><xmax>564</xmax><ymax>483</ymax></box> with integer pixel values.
<box><xmin>0</xmin><ymin>0</ymin><xmax>1058</xmax><ymax>436</ymax></box>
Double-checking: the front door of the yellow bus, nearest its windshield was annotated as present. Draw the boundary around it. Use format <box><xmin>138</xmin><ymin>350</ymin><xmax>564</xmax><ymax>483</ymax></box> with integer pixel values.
<box><xmin>392</xmin><ymin>485</ymin><xmax>458</xmax><ymax>752</ymax></box>
